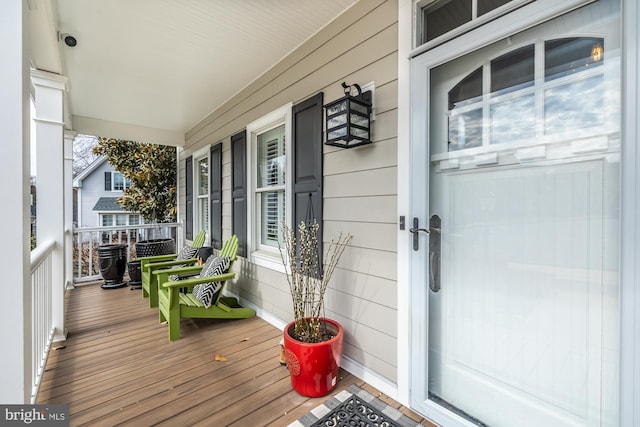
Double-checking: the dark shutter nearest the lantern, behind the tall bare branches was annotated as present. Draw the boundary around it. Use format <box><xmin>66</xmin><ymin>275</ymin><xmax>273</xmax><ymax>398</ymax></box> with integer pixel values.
<box><xmin>292</xmin><ymin>92</ymin><xmax>323</xmax><ymax>259</ymax></box>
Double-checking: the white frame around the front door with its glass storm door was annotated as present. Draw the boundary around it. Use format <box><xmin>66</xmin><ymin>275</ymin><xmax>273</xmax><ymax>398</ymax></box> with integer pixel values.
<box><xmin>397</xmin><ymin>0</ymin><xmax>640</xmax><ymax>425</ymax></box>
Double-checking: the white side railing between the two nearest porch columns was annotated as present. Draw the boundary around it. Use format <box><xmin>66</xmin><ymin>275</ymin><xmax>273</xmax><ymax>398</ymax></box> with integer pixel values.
<box><xmin>31</xmin><ymin>241</ymin><xmax>56</xmax><ymax>403</ymax></box>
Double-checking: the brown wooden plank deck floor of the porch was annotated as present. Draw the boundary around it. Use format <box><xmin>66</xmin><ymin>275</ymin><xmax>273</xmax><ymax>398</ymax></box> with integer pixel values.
<box><xmin>38</xmin><ymin>284</ymin><xmax>432</xmax><ymax>427</ymax></box>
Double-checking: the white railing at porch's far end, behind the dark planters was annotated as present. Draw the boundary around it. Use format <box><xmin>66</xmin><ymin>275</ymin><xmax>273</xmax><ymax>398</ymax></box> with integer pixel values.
<box><xmin>72</xmin><ymin>222</ymin><xmax>183</xmax><ymax>283</ymax></box>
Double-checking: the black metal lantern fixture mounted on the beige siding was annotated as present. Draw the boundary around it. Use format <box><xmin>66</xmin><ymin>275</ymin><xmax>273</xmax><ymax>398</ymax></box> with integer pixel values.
<box><xmin>324</xmin><ymin>82</ymin><xmax>371</xmax><ymax>148</ymax></box>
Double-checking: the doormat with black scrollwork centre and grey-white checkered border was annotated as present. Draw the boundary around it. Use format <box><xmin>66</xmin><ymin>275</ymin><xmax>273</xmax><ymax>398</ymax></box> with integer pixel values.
<box><xmin>289</xmin><ymin>385</ymin><xmax>420</xmax><ymax>427</ymax></box>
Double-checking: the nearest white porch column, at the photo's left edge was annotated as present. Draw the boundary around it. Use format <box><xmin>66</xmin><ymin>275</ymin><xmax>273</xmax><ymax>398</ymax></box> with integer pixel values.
<box><xmin>0</xmin><ymin>0</ymin><xmax>32</xmax><ymax>404</ymax></box>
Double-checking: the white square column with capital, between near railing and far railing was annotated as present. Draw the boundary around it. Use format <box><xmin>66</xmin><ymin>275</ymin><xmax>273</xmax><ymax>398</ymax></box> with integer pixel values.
<box><xmin>31</xmin><ymin>70</ymin><xmax>67</xmax><ymax>341</ymax></box>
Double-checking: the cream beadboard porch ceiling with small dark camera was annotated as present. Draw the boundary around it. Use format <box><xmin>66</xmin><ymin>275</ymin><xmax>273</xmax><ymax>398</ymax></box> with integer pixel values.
<box><xmin>28</xmin><ymin>0</ymin><xmax>356</xmax><ymax>145</ymax></box>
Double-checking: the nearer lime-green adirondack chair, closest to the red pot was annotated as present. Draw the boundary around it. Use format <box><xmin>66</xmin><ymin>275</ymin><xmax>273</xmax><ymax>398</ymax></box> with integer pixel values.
<box><xmin>153</xmin><ymin>235</ymin><xmax>256</xmax><ymax>341</ymax></box>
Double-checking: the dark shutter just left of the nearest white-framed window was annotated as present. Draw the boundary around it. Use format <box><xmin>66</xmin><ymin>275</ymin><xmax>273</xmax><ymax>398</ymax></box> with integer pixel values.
<box><xmin>231</xmin><ymin>131</ymin><xmax>247</xmax><ymax>257</ymax></box>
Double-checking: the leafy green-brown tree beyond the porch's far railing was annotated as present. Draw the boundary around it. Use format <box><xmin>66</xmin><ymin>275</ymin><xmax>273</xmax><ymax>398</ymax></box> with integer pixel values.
<box><xmin>93</xmin><ymin>137</ymin><xmax>177</xmax><ymax>222</ymax></box>
